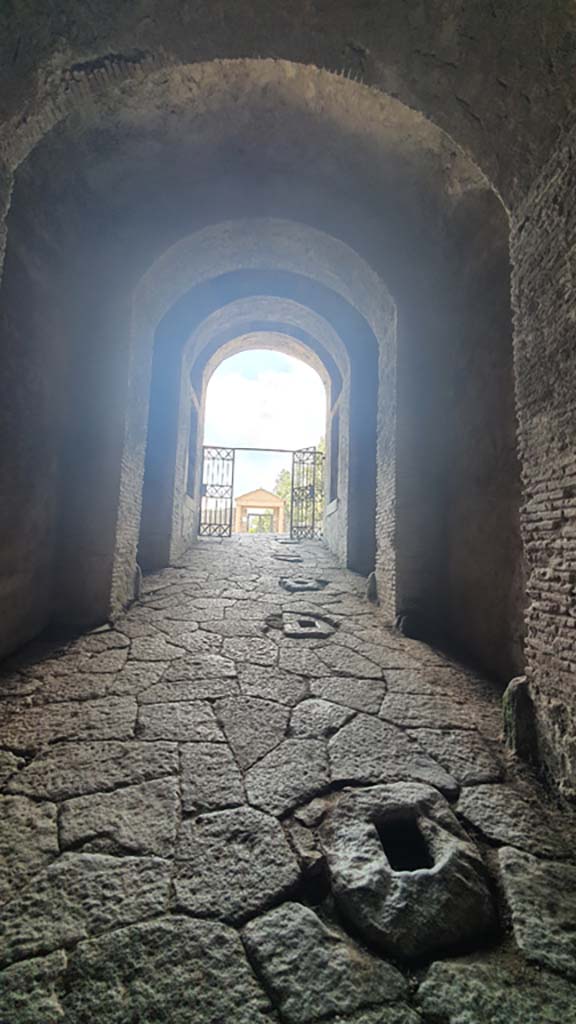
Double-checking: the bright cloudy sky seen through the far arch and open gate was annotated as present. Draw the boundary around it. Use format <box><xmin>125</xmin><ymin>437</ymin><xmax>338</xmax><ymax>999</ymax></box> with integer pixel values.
<box><xmin>204</xmin><ymin>349</ymin><xmax>326</xmax><ymax>496</ymax></box>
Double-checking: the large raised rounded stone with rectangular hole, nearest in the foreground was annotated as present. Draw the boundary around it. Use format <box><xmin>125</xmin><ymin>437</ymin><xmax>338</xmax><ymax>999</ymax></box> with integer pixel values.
<box><xmin>321</xmin><ymin>782</ymin><xmax>495</xmax><ymax>957</ymax></box>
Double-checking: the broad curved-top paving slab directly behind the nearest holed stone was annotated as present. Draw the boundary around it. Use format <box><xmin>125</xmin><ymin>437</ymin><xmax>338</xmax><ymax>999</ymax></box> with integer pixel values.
<box><xmin>328</xmin><ymin>715</ymin><xmax>458</xmax><ymax>796</ymax></box>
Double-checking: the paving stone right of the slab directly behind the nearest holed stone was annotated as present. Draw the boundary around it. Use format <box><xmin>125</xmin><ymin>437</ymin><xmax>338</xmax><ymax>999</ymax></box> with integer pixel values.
<box><xmin>410</xmin><ymin>729</ymin><xmax>502</xmax><ymax>785</ymax></box>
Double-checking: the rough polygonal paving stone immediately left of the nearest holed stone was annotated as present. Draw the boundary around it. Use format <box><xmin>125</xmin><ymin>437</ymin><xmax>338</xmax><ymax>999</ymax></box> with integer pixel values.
<box><xmin>174</xmin><ymin>807</ymin><xmax>298</xmax><ymax>921</ymax></box>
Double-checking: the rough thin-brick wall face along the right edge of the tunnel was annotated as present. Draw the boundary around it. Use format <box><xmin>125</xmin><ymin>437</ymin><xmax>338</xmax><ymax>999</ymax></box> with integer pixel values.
<box><xmin>511</xmin><ymin>121</ymin><xmax>576</xmax><ymax>798</ymax></box>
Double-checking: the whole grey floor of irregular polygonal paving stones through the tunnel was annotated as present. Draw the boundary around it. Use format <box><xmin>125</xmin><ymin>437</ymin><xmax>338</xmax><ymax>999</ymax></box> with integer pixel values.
<box><xmin>0</xmin><ymin>537</ymin><xmax>576</xmax><ymax>1024</ymax></box>
